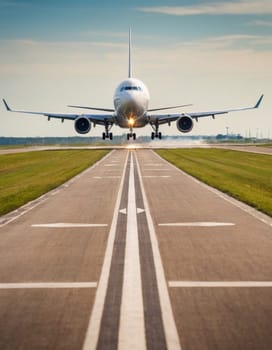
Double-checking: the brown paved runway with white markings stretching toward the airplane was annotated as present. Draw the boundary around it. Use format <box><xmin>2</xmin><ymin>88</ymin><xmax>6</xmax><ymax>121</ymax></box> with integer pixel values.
<box><xmin>0</xmin><ymin>149</ymin><xmax>272</xmax><ymax>350</ymax></box>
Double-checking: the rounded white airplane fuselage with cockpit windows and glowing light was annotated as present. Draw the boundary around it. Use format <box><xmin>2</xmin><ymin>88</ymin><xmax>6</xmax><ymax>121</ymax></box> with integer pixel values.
<box><xmin>113</xmin><ymin>78</ymin><xmax>149</xmax><ymax>129</ymax></box>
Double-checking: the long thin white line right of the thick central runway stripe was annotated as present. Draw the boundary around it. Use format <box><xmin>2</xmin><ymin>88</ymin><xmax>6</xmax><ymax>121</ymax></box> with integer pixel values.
<box><xmin>136</xmin><ymin>155</ymin><xmax>181</xmax><ymax>350</ymax></box>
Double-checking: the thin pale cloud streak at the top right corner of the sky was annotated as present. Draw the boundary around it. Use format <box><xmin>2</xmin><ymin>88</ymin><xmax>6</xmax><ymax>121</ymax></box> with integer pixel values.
<box><xmin>138</xmin><ymin>0</ymin><xmax>272</xmax><ymax>16</ymax></box>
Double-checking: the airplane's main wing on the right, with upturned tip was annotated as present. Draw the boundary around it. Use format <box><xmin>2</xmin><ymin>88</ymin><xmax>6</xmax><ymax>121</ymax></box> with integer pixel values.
<box><xmin>148</xmin><ymin>95</ymin><xmax>264</xmax><ymax>124</ymax></box>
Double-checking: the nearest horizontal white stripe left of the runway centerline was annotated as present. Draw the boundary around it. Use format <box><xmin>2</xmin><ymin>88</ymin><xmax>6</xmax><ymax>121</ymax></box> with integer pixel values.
<box><xmin>0</xmin><ymin>282</ymin><xmax>97</xmax><ymax>289</ymax></box>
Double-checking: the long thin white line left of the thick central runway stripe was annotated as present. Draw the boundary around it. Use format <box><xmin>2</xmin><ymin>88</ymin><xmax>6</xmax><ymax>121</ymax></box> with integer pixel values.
<box><xmin>83</xmin><ymin>152</ymin><xmax>128</xmax><ymax>350</ymax></box>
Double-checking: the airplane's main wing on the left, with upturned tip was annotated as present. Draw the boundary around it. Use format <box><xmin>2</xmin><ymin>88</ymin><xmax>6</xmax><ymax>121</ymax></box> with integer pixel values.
<box><xmin>3</xmin><ymin>99</ymin><xmax>115</xmax><ymax>125</ymax></box>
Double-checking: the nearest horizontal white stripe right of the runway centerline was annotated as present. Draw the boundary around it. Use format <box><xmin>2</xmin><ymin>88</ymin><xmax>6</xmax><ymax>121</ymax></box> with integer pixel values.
<box><xmin>168</xmin><ymin>281</ymin><xmax>272</xmax><ymax>288</ymax></box>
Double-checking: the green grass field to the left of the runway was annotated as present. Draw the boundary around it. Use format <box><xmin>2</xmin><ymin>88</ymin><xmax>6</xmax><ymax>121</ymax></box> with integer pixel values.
<box><xmin>0</xmin><ymin>150</ymin><xmax>108</xmax><ymax>215</ymax></box>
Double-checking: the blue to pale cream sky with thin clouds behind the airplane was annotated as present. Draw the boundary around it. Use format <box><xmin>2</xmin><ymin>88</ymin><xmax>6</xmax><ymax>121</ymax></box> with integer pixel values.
<box><xmin>0</xmin><ymin>0</ymin><xmax>272</xmax><ymax>137</ymax></box>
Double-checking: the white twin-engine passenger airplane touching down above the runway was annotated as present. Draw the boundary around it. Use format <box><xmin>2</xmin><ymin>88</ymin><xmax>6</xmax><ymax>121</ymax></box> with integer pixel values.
<box><xmin>3</xmin><ymin>30</ymin><xmax>263</xmax><ymax>140</ymax></box>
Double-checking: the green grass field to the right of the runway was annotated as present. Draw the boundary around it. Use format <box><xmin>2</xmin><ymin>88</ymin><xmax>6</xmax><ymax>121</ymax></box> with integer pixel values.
<box><xmin>157</xmin><ymin>149</ymin><xmax>272</xmax><ymax>216</ymax></box>
